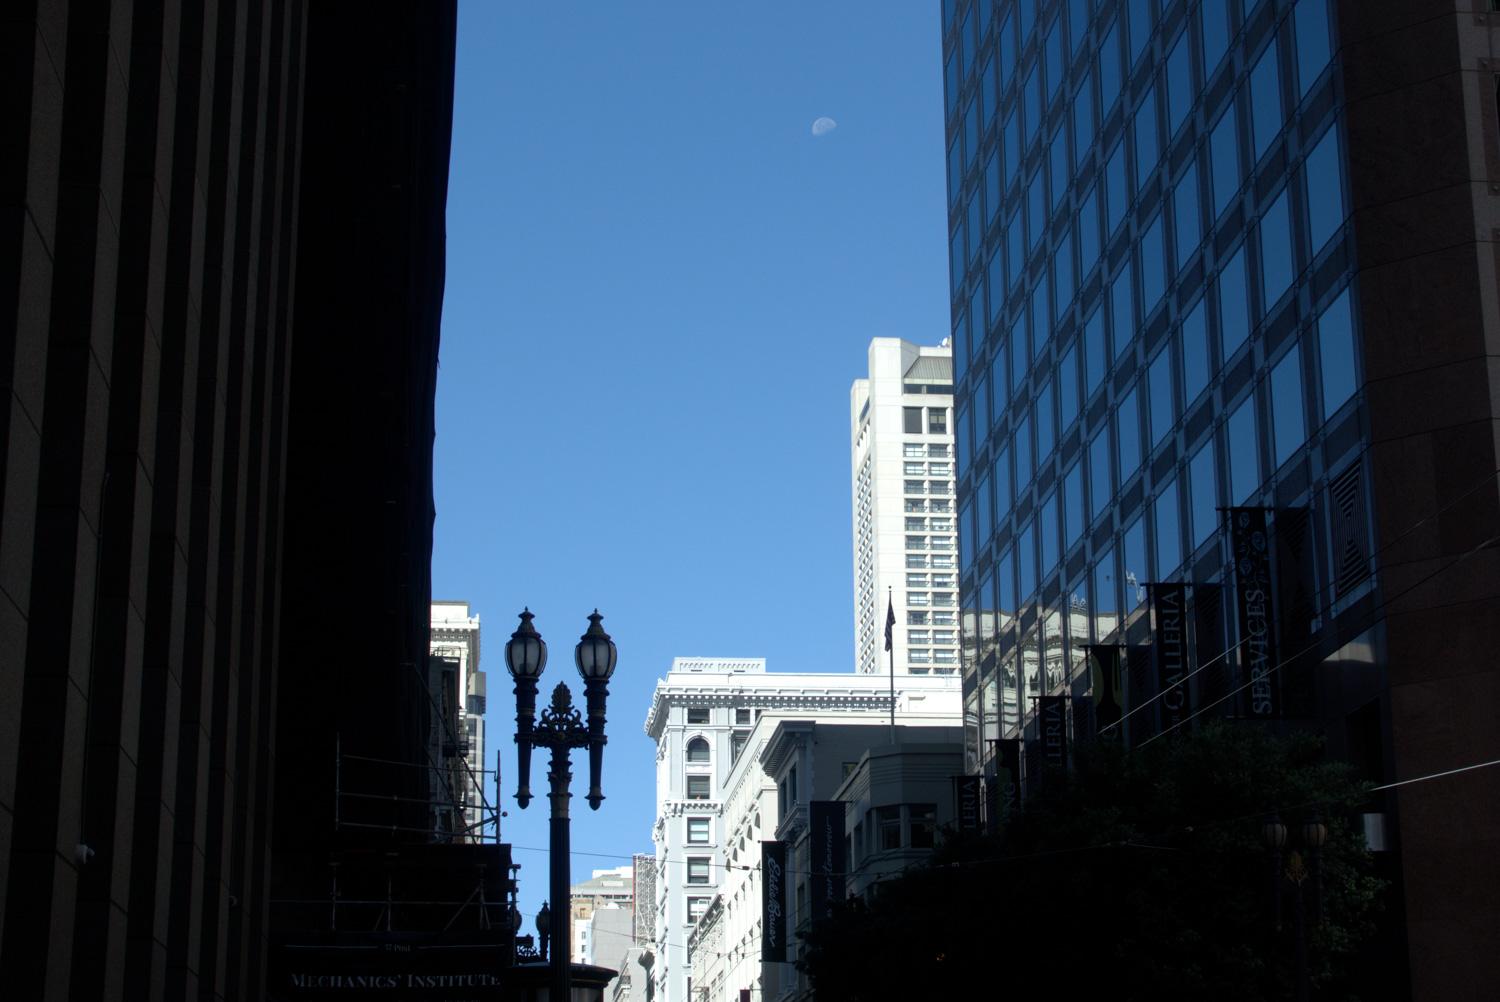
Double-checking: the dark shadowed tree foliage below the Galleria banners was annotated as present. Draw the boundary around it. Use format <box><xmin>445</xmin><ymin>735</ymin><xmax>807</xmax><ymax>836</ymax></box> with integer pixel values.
<box><xmin>800</xmin><ymin>725</ymin><xmax>1382</xmax><ymax>1002</ymax></box>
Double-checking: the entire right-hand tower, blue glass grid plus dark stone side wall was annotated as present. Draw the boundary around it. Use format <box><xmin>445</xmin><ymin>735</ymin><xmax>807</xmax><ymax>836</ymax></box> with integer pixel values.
<box><xmin>944</xmin><ymin>0</ymin><xmax>1500</xmax><ymax>995</ymax></box>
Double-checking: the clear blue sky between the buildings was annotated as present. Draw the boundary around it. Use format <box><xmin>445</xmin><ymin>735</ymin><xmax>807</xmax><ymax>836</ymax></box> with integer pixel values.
<box><xmin>432</xmin><ymin>0</ymin><xmax>948</xmax><ymax>930</ymax></box>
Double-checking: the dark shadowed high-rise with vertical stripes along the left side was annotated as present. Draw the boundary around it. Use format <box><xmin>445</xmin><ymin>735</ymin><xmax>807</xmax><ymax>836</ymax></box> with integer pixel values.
<box><xmin>0</xmin><ymin>0</ymin><xmax>509</xmax><ymax>999</ymax></box>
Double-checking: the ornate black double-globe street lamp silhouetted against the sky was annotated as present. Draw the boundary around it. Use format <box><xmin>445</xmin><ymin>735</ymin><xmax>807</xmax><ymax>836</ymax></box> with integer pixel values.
<box><xmin>506</xmin><ymin>608</ymin><xmax>618</xmax><ymax>1002</ymax></box>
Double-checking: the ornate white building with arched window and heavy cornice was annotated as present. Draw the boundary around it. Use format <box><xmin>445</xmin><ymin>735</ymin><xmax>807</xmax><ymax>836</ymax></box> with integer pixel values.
<box><xmin>636</xmin><ymin>657</ymin><xmax>960</xmax><ymax>1002</ymax></box>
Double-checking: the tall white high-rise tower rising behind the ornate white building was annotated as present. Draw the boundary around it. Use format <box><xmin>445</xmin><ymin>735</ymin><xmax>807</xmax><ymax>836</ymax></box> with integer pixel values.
<box><xmin>849</xmin><ymin>338</ymin><xmax>959</xmax><ymax>675</ymax></box>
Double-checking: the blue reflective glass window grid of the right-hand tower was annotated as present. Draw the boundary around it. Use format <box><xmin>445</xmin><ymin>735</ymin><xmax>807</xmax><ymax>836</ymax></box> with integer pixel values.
<box><xmin>944</xmin><ymin>0</ymin><xmax>1371</xmax><ymax>770</ymax></box>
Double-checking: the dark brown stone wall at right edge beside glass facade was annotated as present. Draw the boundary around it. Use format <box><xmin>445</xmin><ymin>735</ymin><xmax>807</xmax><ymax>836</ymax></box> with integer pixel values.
<box><xmin>1338</xmin><ymin>0</ymin><xmax>1500</xmax><ymax>999</ymax></box>
